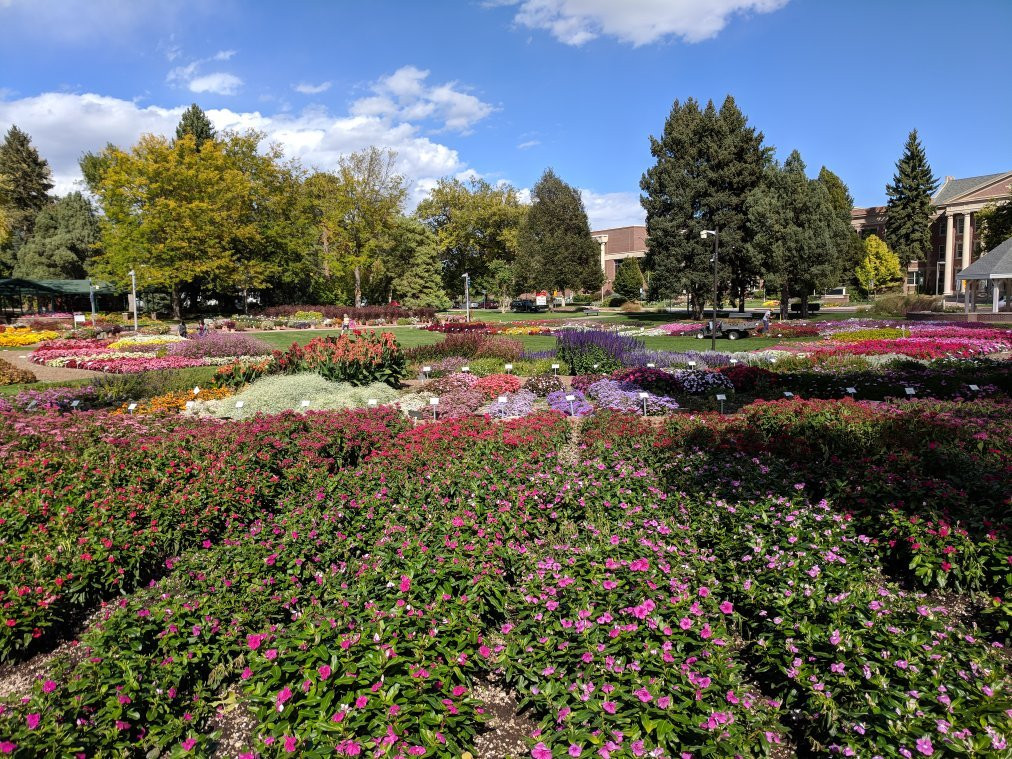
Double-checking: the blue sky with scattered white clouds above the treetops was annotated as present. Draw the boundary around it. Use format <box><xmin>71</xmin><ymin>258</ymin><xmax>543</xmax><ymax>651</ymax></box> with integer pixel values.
<box><xmin>0</xmin><ymin>0</ymin><xmax>1012</xmax><ymax>228</ymax></box>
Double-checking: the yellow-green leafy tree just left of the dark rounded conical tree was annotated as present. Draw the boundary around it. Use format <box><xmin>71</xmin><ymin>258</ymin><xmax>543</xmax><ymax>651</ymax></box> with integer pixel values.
<box><xmin>415</xmin><ymin>177</ymin><xmax>527</xmax><ymax>292</ymax></box>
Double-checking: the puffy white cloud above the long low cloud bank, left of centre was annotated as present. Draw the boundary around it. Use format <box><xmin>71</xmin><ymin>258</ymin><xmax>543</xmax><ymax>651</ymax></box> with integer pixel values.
<box><xmin>351</xmin><ymin>66</ymin><xmax>495</xmax><ymax>134</ymax></box>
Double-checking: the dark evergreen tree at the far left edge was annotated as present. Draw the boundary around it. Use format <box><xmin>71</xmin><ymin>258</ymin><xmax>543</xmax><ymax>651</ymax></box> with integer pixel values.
<box><xmin>0</xmin><ymin>125</ymin><xmax>53</xmax><ymax>276</ymax></box>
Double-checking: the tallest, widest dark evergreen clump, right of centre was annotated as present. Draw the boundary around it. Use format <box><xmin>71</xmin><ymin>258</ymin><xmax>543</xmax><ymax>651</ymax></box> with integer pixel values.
<box><xmin>640</xmin><ymin>96</ymin><xmax>770</xmax><ymax>318</ymax></box>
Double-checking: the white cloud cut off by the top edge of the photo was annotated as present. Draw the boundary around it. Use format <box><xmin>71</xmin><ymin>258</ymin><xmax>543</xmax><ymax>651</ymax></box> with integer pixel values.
<box><xmin>508</xmin><ymin>0</ymin><xmax>787</xmax><ymax>46</ymax></box>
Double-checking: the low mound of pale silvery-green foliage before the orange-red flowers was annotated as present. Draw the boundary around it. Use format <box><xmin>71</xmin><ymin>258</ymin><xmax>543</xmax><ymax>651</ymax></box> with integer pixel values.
<box><xmin>204</xmin><ymin>372</ymin><xmax>399</xmax><ymax>419</ymax></box>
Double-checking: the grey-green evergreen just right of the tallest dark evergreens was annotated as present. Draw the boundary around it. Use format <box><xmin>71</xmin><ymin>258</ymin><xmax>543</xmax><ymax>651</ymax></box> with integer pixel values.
<box><xmin>749</xmin><ymin>150</ymin><xmax>843</xmax><ymax>318</ymax></box>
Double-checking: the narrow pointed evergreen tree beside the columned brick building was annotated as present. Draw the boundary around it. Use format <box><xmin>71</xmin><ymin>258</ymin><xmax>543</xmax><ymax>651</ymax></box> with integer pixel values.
<box><xmin>886</xmin><ymin>130</ymin><xmax>938</xmax><ymax>266</ymax></box>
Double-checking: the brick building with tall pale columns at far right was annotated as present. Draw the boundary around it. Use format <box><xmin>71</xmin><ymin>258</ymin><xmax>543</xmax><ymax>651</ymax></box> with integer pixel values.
<box><xmin>850</xmin><ymin>171</ymin><xmax>1012</xmax><ymax>296</ymax></box>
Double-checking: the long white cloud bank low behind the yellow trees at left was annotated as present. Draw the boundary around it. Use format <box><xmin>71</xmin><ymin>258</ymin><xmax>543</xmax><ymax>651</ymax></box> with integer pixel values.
<box><xmin>0</xmin><ymin>92</ymin><xmax>467</xmax><ymax>204</ymax></box>
